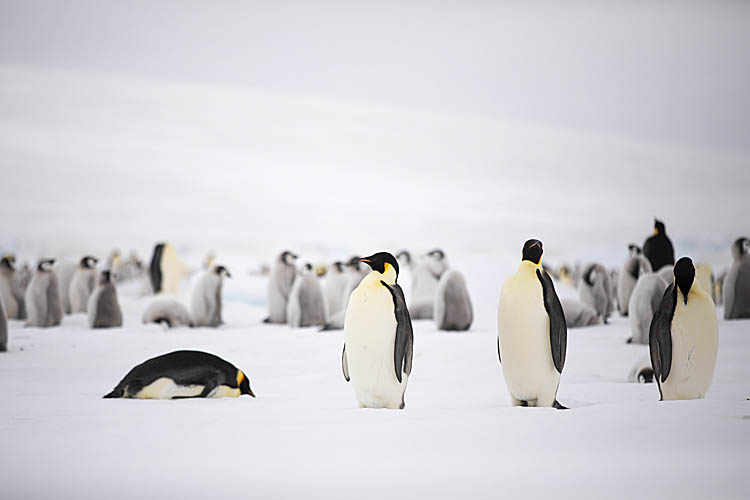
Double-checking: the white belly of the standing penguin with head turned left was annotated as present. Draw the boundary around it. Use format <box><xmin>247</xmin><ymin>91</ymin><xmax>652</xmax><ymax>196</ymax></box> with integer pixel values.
<box><xmin>344</xmin><ymin>283</ymin><xmax>408</xmax><ymax>409</ymax></box>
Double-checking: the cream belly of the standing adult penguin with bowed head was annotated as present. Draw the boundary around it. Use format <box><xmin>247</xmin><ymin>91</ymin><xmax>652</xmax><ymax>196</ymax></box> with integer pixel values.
<box><xmin>661</xmin><ymin>293</ymin><xmax>719</xmax><ymax>400</ymax></box>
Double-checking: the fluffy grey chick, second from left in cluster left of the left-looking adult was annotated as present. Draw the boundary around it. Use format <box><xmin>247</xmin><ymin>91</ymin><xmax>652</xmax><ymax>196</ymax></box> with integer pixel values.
<box><xmin>286</xmin><ymin>263</ymin><xmax>326</xmax><ymax>328</ymax></box>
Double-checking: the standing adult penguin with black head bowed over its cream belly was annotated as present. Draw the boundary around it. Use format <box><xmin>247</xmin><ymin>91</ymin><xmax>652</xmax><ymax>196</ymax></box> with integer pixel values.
<box><xmin>649</xmin><ymin>257</ymin><xmax>719</xmax><ymax>400</ymax></box>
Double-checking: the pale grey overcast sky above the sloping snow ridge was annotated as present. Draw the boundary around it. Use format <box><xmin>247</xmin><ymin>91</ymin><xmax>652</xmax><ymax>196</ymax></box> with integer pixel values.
<box><xmin>0</xmin><ymin>0</ymin><xmax>750</xmax><ymax>156</ymax></box>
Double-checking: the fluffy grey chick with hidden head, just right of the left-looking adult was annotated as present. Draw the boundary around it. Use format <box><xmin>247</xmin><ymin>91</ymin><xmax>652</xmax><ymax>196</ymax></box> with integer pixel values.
<box><xmin>433</xmin><ymin>269</ymin><xmax>474</xmax><ymax>331</ymax></box>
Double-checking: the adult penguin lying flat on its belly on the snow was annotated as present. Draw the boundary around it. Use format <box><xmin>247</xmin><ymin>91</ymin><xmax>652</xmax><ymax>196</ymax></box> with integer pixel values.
<box><xmin>104</xmin><ymin>351</ymin><xmax>255</xmax><ymax>399</ymax></box>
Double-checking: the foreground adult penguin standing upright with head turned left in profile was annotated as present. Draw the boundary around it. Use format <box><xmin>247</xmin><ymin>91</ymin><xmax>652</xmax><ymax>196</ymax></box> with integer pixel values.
<box><xmin>341</xmin><ymin>252</ymin><xmax>414</xmax><ymax>409</ymax></box>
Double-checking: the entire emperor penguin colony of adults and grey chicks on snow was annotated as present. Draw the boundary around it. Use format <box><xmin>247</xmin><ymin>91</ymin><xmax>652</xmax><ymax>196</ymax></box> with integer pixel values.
<box><xmin>0</xmin><ymin>220</ymin><xmax>750</xmax><ymax>409</ymax></box>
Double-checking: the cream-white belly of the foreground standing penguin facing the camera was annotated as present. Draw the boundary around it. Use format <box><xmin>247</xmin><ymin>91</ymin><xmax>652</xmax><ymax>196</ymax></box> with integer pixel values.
<box><xmin>498</xmin><ymin>275</ymin><xmax>560</xmax><ymax>406</ymax></box>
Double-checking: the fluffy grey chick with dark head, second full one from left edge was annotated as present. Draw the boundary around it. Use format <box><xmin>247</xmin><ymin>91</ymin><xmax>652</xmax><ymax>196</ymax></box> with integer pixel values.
<box><xmin>25</xmin><ymin>259</ymin><xmax>63</xmax><ymax>327</ymax></box>
